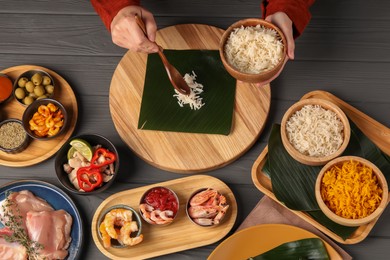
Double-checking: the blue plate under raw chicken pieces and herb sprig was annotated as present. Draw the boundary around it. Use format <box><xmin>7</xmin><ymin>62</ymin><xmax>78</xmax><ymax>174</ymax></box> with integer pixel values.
<box><xmin>0</xmin><ymin>180</ymin><xmax>83</xmax><ymax>260</ymax></box>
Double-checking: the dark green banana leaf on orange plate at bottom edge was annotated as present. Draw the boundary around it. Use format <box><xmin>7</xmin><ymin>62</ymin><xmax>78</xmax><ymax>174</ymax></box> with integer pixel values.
<box><xmin>249</xmin><ymin>238</ymin><xmax>329</xmax><ymax>260</ymax></box>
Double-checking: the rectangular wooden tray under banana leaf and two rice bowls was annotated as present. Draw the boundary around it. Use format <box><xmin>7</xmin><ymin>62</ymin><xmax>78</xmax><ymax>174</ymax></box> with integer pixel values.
<box><xmin>252</xmin><ymin>91</ymin><xmax>390</xmax><ymax>244</ymax></box>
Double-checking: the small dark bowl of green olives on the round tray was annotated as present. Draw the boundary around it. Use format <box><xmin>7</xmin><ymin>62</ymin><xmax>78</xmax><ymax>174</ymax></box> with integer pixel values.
<box><xmin>13</xmin><ymin>69</ymin><xmax>54</xmax><ymax>106</ymax></box>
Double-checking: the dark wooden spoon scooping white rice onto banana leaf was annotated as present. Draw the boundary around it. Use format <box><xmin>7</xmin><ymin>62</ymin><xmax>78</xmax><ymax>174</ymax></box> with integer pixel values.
<box><xmin>135</xmin><ymin>15</ymin><xmax>191</xmax><ymax>95</ymax></box>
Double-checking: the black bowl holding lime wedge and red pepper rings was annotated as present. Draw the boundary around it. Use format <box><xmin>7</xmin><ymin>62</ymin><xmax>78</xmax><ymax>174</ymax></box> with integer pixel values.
<box><xmin>55</xmin><ymin>134</ymin><xmax>119</xmax><ymax>195</ymax></box>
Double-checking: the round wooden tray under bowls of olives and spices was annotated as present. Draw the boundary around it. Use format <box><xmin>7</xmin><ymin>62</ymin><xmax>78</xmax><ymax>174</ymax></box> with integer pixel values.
<box><xmin>0</xmin><ymin>65</ymin><xmax>78</xmax><ymax>167</ymax></box>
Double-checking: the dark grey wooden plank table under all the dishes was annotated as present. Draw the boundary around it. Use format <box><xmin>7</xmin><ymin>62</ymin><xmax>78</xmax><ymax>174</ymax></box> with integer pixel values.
<box><xmin>0</xmin><ymin>0</ymin><xmax>390</xmax><ymax>259</ymax></box>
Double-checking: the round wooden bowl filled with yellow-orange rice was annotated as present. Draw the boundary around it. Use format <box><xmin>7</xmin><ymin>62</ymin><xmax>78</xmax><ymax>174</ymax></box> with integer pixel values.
<box><xmin>315</xmin><ymin>156</ymin><xmax>389</xmax><ymax>227</ymax></box>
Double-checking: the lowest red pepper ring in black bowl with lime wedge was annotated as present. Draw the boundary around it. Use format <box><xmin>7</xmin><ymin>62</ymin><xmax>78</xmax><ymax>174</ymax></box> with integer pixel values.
<box><xmin>77</xmin><ymin>167</ymin><xmax>103</xmax><ymax>192</ymax></box>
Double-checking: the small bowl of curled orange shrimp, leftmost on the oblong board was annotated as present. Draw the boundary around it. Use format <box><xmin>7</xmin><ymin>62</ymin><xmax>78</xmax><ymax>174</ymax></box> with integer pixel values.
<box><xmin>97</xmin><ymin>204</ymin><xmax>143</xmax><ymax>249</ymax></box>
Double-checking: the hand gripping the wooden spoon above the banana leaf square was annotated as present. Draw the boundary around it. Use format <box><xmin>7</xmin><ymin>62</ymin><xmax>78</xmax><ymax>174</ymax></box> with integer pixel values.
<box><xmin>111</xmin><ymin>5</ymin><xmax>158</xmax><ymax>53</ymax></box>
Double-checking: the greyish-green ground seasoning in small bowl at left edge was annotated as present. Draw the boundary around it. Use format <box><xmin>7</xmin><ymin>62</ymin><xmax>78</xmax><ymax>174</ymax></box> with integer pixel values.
<box><xmin>0</xmin><ymin>122</ymin><xmax>27</xmax><ymax>149</ymax></box>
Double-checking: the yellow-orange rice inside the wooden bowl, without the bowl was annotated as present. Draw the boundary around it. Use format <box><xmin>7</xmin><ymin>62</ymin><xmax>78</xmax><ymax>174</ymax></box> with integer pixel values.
<box><xmin>321</xmin><ymin>160</ymin><xmax>383</xmax><ymax>219</ymax></box>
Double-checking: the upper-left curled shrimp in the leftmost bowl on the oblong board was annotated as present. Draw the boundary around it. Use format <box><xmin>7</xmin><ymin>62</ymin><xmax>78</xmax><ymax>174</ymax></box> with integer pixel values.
<box><xmin>103</xmin><ymin>209</ymin><xmax>133</xmax><ymax>239</ymax></box>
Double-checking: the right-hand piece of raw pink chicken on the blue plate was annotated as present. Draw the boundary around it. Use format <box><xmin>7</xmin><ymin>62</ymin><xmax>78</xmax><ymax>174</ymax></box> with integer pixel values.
<box><xmin>26</xmin><ymin>209</ymin><xmax>73</xmax><ymax>259</ymax></box>
